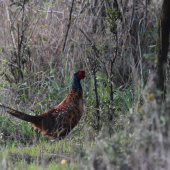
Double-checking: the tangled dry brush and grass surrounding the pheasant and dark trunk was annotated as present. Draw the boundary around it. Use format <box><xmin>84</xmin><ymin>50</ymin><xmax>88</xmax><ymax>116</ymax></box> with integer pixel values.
<box><xmin>0</xmin><ymin>0</ymin><xmax>170</xmax><ymax>170</ymax></box>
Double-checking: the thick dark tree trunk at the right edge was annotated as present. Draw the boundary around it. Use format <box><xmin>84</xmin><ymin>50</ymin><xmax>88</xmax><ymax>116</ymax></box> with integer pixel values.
<box><xmin>156</xmin><ymin>0</ymin><xmax>170</xmax><ymax>98</ymax></box>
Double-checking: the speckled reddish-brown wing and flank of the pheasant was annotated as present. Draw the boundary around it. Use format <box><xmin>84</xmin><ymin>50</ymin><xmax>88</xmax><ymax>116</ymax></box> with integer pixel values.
<box><xmin>41</xmin><ymin>103</ymin><xmax>81</xmax><ymax>138</ymax></box>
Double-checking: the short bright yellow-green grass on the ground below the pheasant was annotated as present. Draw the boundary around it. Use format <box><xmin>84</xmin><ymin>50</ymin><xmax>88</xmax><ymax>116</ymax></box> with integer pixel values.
<box><xmin>0</xmin><ymin>136</ymin><xmax>89</xmax><ymax>169</ymax></box>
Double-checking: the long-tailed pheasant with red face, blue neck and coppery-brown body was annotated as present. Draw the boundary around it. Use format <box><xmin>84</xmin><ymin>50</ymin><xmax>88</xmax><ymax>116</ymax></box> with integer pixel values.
<box><xmin>0</xmin><ymin>70</ymin><xmax>85</xmax><ymax>139</ymax></box>
